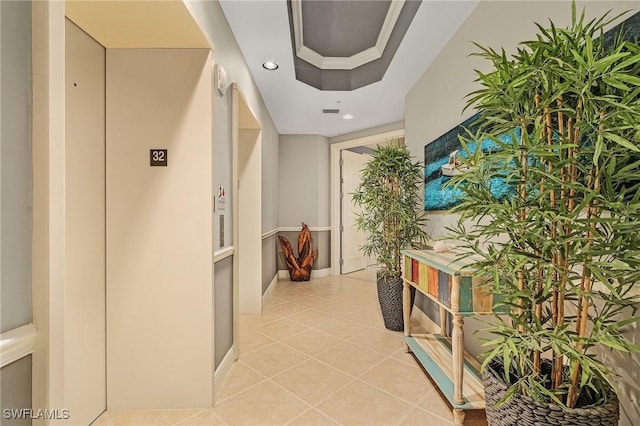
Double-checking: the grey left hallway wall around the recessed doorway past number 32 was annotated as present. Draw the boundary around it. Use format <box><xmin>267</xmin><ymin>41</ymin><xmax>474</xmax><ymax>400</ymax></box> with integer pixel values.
<box><xmin>184</xmin><ymin>0</ymin><xmax>279</xmax><ymax>367</ymax></box>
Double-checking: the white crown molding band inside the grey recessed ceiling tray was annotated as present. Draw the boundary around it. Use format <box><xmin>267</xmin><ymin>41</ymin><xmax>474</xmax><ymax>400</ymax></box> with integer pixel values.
<box><xmin>291</xmin><ymin>0</ymin><xmax>405</xmax><ymax>70</ymax></box>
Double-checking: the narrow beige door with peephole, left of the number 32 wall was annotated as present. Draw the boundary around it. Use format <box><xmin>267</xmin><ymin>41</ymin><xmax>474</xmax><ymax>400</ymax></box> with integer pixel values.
<box><xmin>64</xmin><ymin>20</ymin><xmax>106</xmax><ymax>425</ymax></box>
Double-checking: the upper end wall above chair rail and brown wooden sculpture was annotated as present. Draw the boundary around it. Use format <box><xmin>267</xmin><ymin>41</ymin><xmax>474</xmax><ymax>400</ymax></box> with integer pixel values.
<box><xmin>278</xmin><ymin>135</ymin><xmax>331</xmax><ymax>228</ymax></box>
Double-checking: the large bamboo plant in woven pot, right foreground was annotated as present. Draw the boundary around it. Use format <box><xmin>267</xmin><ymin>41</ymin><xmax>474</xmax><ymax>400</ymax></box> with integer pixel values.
<box><xmin>449</xmin><ymin>4</ymin><xmax>640</xmax><ymax>425</ymax></box>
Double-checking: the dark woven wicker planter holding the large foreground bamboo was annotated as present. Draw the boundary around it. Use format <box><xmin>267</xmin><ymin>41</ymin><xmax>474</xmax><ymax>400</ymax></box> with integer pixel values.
<box><xmin>482</xmin><ymin>362</ymin><xmax>620</xmax><ymax>426</ymax></box>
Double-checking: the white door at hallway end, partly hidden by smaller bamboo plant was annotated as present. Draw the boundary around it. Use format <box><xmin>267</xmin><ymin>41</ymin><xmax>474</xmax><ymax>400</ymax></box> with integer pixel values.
<box><xmin>340</xmin><ymin>150</ymin><xmax>370</xmax><ymax>274</ymax></box>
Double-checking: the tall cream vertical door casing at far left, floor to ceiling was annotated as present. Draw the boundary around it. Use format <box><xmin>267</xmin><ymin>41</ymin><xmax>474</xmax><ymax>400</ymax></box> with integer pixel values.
<box><xmin>31</xmin><ymin>1</ymin><xmax>66</xmax><ymax>412</ymax></box>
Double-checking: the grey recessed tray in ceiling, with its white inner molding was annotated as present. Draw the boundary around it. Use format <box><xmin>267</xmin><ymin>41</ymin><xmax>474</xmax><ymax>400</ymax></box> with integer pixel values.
<box><xmin>287</xmin><ymin>0</ymin><xmax>420</xmax><ymax>90</ymax></box>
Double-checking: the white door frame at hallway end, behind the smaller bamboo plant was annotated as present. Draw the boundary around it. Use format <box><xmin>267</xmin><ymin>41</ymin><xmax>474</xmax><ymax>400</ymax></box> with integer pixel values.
<box><xmin>331</xmin><ymin>128</ymin><xmax>405</xmax><ymax>275</ymax></box>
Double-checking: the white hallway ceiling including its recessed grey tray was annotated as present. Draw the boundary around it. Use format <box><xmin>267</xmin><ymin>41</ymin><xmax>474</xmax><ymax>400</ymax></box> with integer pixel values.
<box><xmin>220</xmin><ymin>0</ymin><xmax>478</xmax><ymax>137</ymax></box>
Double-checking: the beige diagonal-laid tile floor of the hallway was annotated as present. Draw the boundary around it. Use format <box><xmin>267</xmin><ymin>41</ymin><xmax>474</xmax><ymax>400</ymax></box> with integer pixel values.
<box><xmin>93</xmin><ymin>270</ymin><xmax>486</xmax><ymax>426</ymax></box>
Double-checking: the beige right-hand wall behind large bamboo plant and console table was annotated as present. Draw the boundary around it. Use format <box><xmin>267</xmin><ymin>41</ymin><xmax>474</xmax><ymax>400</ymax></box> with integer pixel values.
<box><xmin>405</xmin><ymin>1</ymin><xmax>640</xmax><ymax>425</ymax></box>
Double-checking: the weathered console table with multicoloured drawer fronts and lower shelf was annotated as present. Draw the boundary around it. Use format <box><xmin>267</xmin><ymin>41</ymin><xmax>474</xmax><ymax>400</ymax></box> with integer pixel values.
<box><xmin>402</xmin><ymin>250</ymin><xmax>493</xmax><ymax>426</ymax></box>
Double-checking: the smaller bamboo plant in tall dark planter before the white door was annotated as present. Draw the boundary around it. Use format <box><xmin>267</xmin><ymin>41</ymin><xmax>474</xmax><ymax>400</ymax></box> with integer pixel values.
<box><xmin>353</xmin><ymin>140</ymin><xmax>427</xmax><ymax>331</ymax></box>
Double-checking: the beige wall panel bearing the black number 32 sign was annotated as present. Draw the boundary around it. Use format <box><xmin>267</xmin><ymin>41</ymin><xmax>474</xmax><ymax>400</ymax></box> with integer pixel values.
<box><xmin>106</xmin><ymin>49</ymin><xmax>213</xmax><ymax>409</ymax></box>
